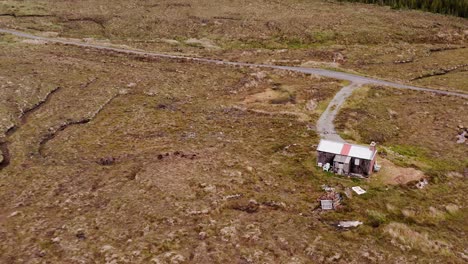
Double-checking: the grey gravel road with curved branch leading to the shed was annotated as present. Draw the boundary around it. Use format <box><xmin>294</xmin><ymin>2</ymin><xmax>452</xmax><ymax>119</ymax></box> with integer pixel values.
<box><xmin>0</xmin><ymin>29</ymin><xmax>468</xmax><ymax>141</ymax></box>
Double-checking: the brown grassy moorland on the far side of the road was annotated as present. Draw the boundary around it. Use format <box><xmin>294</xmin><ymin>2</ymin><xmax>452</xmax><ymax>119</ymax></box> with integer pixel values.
<box><xmin>0</xmin><ymin>0</ymin><xmax>468</xmax><ymax>91</ymax></box>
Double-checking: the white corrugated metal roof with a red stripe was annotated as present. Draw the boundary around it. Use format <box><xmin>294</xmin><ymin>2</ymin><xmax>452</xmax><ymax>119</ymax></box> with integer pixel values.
<box><xmin>317</xmin><ymin>139</ymin><xmax>375</xmax><ymax>160</ymax></box>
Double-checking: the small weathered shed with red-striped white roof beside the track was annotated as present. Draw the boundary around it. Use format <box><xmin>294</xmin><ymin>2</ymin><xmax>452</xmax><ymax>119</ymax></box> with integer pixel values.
<box><xmin>317</xmin><ymin>139</ymin><xmax>378</xmax><ymax>177</ymax></box>
